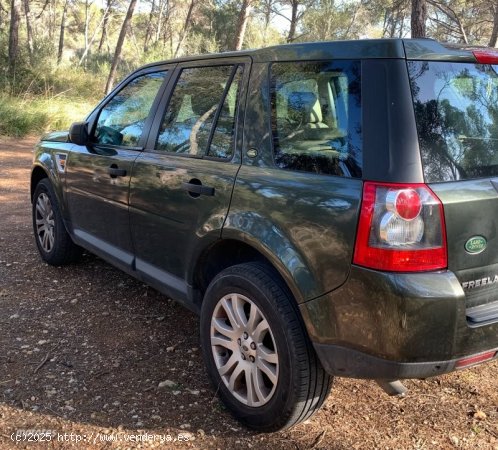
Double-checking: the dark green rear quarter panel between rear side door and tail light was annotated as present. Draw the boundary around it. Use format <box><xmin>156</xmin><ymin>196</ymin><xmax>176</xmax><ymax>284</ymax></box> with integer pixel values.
<box><xmin>223</xmin><ymin>166</ymin><xmax>362</xmax><ymax>302</ymax></box>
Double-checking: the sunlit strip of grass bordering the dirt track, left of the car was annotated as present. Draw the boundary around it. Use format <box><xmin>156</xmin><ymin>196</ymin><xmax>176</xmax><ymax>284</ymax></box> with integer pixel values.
<box><xmin>0</xmin><ymin>95</ymin><xmax>95</xmax><ymax>137</ymax></box>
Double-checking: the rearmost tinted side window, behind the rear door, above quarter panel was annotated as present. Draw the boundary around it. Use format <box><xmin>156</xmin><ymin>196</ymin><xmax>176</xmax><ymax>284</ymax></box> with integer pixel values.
<box><xmin>271</xmin><ymin>61</ymin><xmax>362</xmax><ymax>178</ymax></box>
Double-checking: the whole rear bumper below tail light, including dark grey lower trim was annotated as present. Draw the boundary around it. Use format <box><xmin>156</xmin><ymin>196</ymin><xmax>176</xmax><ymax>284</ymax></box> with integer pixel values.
<box><xmin>300</xmin><ymin>266</ymin><xmax>498</xmax><ymax>379</ymax></box>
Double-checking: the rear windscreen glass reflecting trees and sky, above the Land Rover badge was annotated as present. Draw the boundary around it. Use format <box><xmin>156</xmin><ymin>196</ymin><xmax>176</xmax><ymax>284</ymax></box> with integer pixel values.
<box><xmin>408</xmin><ymin>61</ymin><xmax>498</xmax><ymax>183</ymax></box>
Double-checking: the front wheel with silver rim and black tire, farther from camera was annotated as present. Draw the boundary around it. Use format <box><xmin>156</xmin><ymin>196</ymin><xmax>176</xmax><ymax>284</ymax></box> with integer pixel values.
<box><xmin>32</xmin><ymin>178</ymin><xmax>82</xmax><ymax>266</ymax></box>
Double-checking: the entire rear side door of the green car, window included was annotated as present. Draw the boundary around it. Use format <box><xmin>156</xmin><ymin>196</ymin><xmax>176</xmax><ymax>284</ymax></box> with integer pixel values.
<box><xmin>130</xmin><ymin>58</ymin><xmax>250</xmax><ymax>300</ymax></box>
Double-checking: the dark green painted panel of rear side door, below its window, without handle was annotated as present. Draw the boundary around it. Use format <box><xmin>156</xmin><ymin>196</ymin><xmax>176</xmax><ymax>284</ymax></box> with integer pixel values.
<box><xmin>130</xmin><ymin>152</ymin><xmax>239</xmax><ymax>280</ymax></box>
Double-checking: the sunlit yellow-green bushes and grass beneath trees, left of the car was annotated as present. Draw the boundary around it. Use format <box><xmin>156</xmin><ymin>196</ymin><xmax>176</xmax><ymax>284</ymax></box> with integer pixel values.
<box><xmin>0</xmin><ymin>38</ymin><xmax>132</xmax><ymax>137</ymax></box>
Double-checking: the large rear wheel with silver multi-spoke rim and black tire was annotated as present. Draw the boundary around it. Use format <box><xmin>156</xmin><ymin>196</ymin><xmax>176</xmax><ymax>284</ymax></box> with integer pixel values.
<box><xmin>200</xmin><ymin>263</ymin><xmax>332</xmax><ymax>432</ymax></box>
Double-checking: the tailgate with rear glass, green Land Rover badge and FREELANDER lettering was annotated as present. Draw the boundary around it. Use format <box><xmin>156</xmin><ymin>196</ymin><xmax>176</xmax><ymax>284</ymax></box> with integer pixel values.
<box><xmin>408</xmin><ymin>60</ymin><xmax>498</xmax><ymax>325</ymax></box>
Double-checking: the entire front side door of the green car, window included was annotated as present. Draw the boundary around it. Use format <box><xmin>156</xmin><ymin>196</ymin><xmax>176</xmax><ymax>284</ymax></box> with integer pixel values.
<box><xmin>66</xmin><ymin>67</ymin><xmax>168</xmax><ymax>269</ymax></box>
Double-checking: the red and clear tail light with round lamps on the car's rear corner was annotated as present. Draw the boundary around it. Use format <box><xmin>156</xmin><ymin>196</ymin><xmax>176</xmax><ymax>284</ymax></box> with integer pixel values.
<box><xmin>353</xmin><ymin>181</ymin><xmax>447</xmax><ymax>272</ymax></box>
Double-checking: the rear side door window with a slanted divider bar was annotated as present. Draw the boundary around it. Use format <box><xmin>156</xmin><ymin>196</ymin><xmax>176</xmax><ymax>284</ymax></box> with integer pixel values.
<box><xmin>156</xmin><ymin>65</ymin><xmax>242</xmax><ymax>158</ymax></box>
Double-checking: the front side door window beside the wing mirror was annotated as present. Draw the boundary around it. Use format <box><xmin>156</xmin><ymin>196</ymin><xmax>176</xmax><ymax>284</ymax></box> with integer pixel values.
<box><xmin>94</xmin><ymin>71</ymin><xmax>167</xmax><ymax>147</ymax></box>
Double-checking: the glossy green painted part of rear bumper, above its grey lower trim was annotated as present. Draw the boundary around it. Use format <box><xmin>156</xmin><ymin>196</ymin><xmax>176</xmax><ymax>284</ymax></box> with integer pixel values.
<box><xmin>301</xmin><ymin>266</ymin><xmax>468</xmax><ymax>362</ymax></box>
